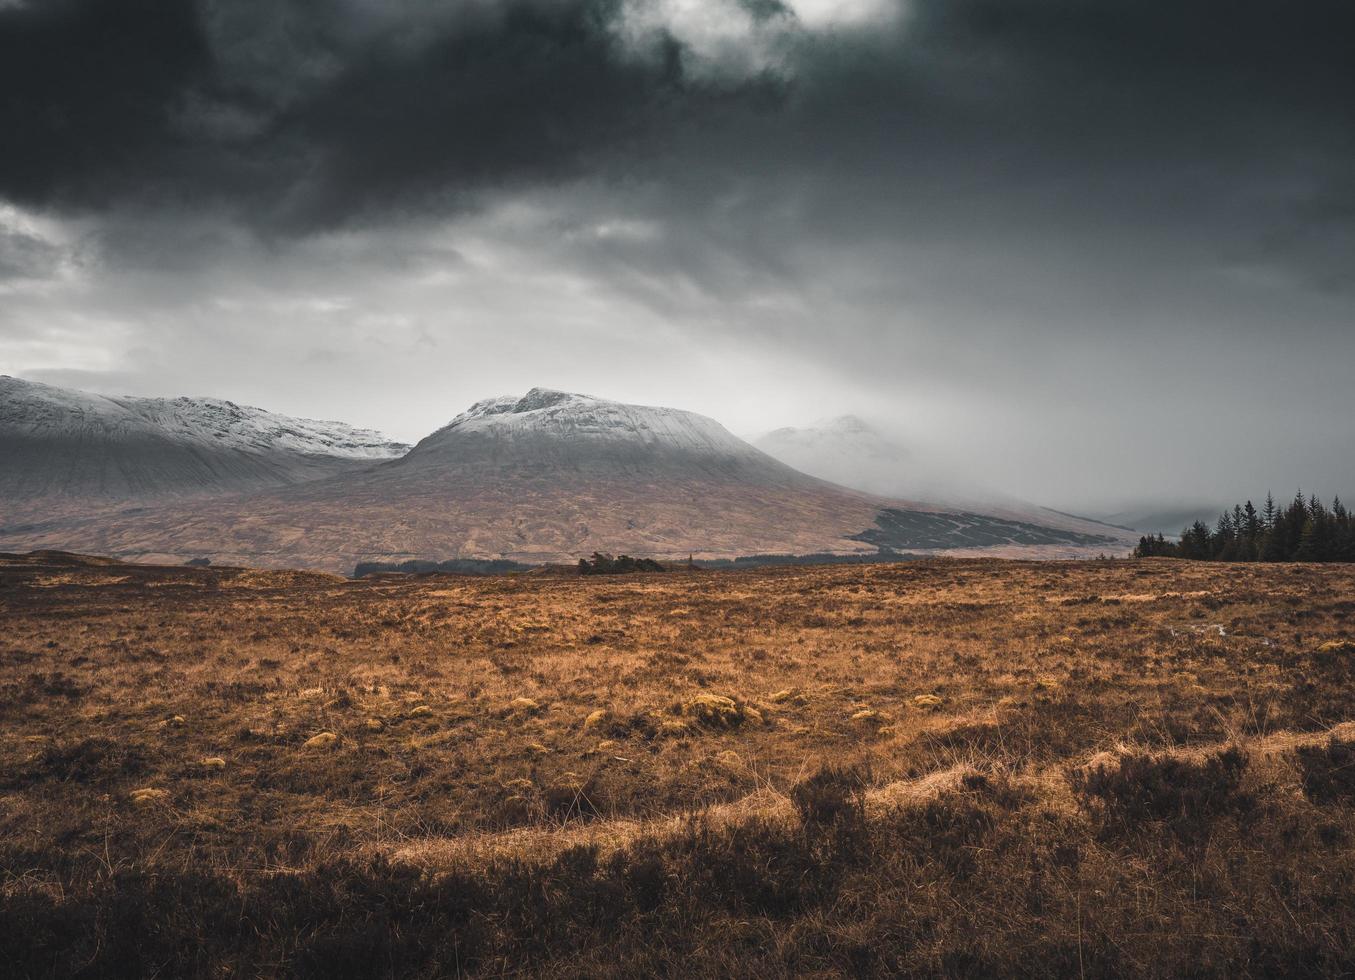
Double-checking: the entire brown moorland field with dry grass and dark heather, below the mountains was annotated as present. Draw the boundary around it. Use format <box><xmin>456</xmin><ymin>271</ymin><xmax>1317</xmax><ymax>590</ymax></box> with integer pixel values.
<box><xmin>0</xmin><ymin>554</ymin><xmax>1355</xmax><ymax>977</ymax></box>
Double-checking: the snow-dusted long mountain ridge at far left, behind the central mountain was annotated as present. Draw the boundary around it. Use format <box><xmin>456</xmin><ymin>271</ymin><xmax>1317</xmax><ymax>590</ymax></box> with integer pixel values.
<box><xmin>0</xmin><ymin>375</ymin><xmax>408</xmax><ymax>516</ymax></box>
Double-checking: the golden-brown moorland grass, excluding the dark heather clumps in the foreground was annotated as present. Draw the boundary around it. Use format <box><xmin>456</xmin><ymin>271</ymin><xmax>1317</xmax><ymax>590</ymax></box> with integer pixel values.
<box><xmin>0</xmin><ymin>560</ymin><xmax>1355</xmax><ymax>975</ymax></box>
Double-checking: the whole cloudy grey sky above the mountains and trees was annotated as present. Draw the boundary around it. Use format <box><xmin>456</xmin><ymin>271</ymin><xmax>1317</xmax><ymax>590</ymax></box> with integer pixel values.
<box><xmin>0</xmin><ymin>0</ymin><xmax>1355</xmax><ymax>512</ymax></box>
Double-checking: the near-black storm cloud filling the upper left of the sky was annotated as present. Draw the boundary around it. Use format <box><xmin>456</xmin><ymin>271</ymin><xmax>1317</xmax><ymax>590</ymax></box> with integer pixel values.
<box><xmin>0</xmin><ymin>0</ymin><xmax>775</xmax><ymax>229</ymax></box>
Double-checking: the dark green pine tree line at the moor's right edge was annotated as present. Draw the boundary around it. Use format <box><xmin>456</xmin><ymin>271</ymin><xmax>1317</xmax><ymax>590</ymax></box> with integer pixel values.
<box><xmin>1134</xmin><ymin>492</ymin><xmax>1355</xmax><ymax>561</ymax></box>
